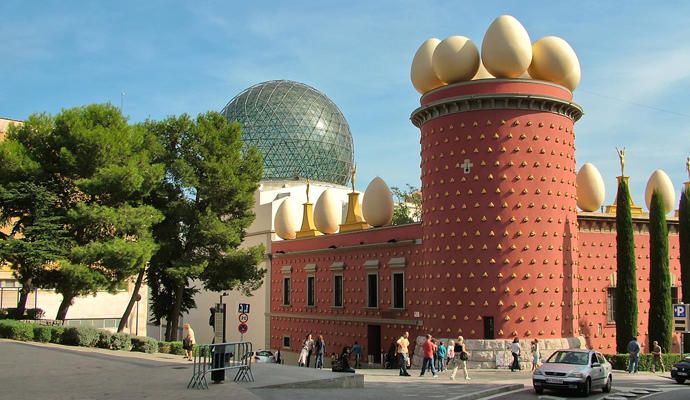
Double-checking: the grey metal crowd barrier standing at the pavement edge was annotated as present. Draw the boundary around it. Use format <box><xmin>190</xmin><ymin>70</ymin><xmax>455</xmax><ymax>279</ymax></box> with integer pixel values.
<box><xmin>187</xmin><ymin>342</ymin><xmax>254</xmax><ymax>389</ymax></box>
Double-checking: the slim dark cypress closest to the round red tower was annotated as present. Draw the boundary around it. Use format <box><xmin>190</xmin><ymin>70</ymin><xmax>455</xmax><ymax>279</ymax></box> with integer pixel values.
<box><xmin>615</xmin><ymin>179</ymin><xmax>637</xmax><ymax>353</ymax></box>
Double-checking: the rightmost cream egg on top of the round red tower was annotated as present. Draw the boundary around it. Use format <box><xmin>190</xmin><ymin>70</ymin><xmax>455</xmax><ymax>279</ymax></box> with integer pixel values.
<box><xmin>529</xmin><ymin>36</ymin><xmax>581</xmax><ymax>91</ymax></box>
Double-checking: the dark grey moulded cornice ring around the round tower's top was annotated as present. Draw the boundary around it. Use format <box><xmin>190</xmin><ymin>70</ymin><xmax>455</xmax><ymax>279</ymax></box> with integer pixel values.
<box><xmin>410</xmin><ymin>93</ymin><xmax>583</xmax><ymax>128</ymax></box>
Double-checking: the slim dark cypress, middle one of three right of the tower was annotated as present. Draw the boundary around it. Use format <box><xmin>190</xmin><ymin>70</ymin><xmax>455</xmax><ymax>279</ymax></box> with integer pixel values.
<box><xmin>647</xmin><ymin>191</ymin><xmax>673</xmax><ymax>349</ymax></box>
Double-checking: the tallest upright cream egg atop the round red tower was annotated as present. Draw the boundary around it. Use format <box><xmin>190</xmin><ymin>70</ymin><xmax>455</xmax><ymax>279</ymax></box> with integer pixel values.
<box><xmin>482</xmin><ymin>15</ymin><xmax>532</xmax><ymax>78</ymax></box>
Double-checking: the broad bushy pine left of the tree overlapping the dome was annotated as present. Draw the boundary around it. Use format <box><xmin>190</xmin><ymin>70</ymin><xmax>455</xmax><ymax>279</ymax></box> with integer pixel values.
<box><xmin>0</xmin><ymin>104</ymin><xmax>163</xmax><ymax>319</ymax></box>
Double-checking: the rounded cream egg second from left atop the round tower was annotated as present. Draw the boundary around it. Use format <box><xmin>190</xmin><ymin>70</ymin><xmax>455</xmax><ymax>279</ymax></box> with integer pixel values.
<box><xmin>431</xmin><ymin>36</ymin><xmax>479</xmax><ymax>83</ymax></box>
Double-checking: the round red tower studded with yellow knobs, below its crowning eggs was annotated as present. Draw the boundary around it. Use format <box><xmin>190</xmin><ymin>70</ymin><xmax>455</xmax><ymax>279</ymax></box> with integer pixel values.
<box><xmin>411</xmin><ymin>79</ymin><xmax>582</xmax><ymax>339</ymax></box>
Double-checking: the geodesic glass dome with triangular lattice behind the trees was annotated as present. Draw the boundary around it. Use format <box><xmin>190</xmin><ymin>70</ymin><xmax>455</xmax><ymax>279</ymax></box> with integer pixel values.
<box><xmin>223</xmin><ymin>80</ymin><xmax>354</xmax><ymax>185</ymax></box>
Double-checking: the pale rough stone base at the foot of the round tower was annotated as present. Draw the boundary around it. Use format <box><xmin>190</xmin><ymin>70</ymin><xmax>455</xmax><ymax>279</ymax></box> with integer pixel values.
<box><xmin>412</xmin><ymin>336</ymin><xmax>587</xmax><ymax>369</ymax></box>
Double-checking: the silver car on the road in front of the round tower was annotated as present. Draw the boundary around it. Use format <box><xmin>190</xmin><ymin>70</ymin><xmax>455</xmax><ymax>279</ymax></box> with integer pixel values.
<box><xmin>532</xmin><ymin>349</ymin><xmax>613</xmax><ymax>396</ymax></box>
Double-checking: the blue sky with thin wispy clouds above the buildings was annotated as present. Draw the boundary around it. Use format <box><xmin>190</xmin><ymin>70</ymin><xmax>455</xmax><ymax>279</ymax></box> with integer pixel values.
<box><xmin>0</xmin><ymin>0</ymin><xmax>690</xmax><ymax>206</ymax></box>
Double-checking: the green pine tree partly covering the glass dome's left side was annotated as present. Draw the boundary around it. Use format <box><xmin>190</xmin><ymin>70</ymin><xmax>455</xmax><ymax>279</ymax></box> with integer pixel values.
<box><xmin>144</xmin><ymin>112</ymin><xmax>265</xmax><ymax>340</ymax></box>
